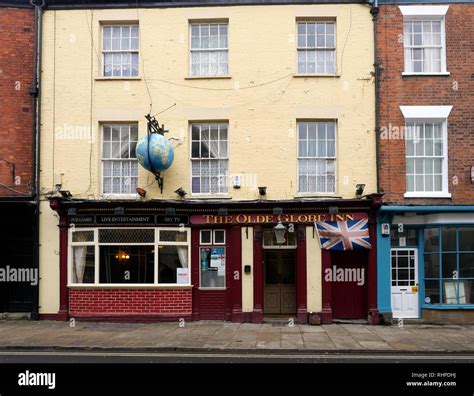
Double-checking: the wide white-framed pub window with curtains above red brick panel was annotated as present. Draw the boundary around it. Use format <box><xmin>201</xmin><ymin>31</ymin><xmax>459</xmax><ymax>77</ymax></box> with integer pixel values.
<box><xmin>69</xmin><ymin>228</ymin><xmax>190</xmax><ymax>285</ymax></box>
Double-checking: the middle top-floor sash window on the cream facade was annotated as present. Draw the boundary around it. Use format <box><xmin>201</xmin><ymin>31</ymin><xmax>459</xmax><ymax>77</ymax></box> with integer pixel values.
<box><xmin>190</xmin><ymin>22</ymin><xmax>229</xmax><ymax>77</ymax></box>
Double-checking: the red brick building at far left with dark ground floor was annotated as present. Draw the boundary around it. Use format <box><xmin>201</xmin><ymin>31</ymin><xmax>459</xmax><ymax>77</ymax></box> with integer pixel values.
<box><xmin>0</xmin><ymin>1</ymin><xmax>38</xmax><ymax>314</ymax></box>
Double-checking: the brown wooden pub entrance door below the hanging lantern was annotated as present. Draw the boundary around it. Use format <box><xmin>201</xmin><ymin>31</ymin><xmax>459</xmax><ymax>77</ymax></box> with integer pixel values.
<box><xmin>264</xmin><ymin>250</ymin><xmax>296</xmax><ymax>314</ymax></box>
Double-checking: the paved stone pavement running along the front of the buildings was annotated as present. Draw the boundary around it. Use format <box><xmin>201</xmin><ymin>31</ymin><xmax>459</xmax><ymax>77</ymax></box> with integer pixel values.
<box><xmin>0</xmin><ymin>320</ymin><xmax>474</xmax><ymax>355</ymax></box>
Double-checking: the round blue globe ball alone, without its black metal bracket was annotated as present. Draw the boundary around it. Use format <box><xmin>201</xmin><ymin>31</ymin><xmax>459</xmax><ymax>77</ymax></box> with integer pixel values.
<box><xmin>136</xmin><ymin>133</ymin><xmax>174</xmax><ymax>173</ymax></box>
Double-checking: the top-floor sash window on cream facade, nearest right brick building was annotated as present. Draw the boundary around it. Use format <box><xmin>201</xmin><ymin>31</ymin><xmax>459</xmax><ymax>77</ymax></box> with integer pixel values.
<box><xmin>297</xmin><ymin>21</ymin><xmax>336</xmax><ymax>74</ymax></box>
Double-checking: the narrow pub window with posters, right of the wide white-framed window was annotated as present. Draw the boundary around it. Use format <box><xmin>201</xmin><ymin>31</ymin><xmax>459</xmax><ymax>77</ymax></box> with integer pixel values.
<box><xmin>199</xmin><ymin>230</ymin><xmax>226</xmax><ymax>288</ymax></box>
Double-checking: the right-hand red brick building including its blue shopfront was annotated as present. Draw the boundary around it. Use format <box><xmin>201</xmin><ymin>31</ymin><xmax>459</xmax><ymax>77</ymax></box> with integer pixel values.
<box><xmin>376</xmin><ymin>0</ymin><xmax>474</xmax><ymax>321</ymax></box>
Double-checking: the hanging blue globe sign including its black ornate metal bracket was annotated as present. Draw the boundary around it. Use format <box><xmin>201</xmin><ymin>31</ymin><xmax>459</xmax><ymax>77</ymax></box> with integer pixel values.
<box><xmin>136</xmin><ymin>114</ymin><xmax>174</xmax><ymax>193</ymax></box>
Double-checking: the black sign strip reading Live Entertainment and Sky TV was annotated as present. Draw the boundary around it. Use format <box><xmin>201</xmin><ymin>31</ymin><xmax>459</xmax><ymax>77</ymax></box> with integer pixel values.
<box><xmin>68</xmin><ymin>214</ymin><xmax>189</xmax><ymax>226</ymax></box>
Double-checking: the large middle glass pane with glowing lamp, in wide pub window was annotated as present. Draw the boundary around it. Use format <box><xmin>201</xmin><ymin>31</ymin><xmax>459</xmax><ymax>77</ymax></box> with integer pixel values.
<box><xmin>99</xmin><ymin>245</ymin><xmax>155</xmax><ymax>284</ymax></box>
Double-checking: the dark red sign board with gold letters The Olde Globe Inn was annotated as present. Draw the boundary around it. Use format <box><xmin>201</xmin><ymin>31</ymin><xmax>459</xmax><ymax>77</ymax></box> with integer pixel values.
<box><xmin>191</xmin><ymin>213</ymin><xmax>368</xmax><ymax>224</ymax></box>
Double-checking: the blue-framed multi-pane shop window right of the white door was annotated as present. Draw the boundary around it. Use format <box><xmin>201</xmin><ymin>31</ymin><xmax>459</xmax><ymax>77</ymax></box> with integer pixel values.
<box><xmin>424</xmin><ymin>226</ymin><xmax>474</xmax><ymax>305</ymax></box>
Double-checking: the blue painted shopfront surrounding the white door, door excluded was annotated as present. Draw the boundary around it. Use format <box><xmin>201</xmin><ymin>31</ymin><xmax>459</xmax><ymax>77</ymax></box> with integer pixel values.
<box><xmin>377</xmin><ymin>206</ymin><xmax>474</xmax><ymax>318</ymax></box>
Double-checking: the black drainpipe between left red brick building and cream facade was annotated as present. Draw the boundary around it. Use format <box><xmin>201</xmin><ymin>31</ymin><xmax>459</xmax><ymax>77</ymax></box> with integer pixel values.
<box><xmin>28</xmin><ymin>0</ymin><xmax>44</xmax><ymax>320</ymax></box>
